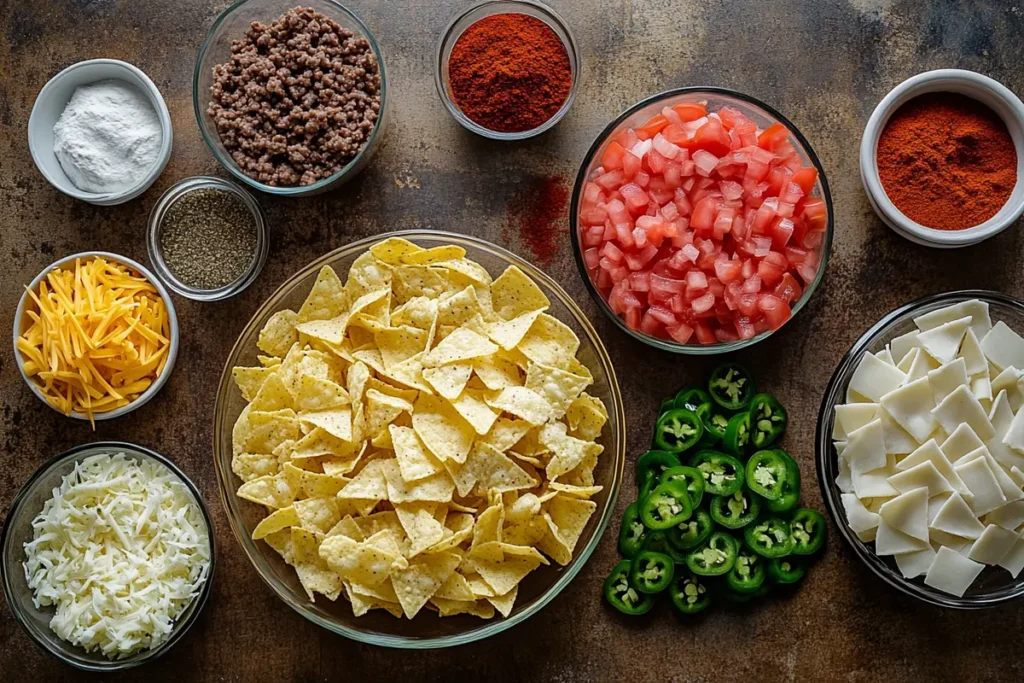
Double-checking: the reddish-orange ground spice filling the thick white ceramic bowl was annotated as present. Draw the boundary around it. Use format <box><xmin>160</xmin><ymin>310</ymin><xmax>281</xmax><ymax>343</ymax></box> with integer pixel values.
<box><xmin>877</xmin><ymin>92</ymin><xmax>1017</xmax><ymax>230</ymax></box>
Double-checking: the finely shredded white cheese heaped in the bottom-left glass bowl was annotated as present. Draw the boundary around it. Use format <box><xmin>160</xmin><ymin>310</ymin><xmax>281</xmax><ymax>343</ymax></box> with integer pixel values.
<box><xmin>25</xmin><ymin>453</ymin><xmax>210</xmax><ymax>658</ymax></box>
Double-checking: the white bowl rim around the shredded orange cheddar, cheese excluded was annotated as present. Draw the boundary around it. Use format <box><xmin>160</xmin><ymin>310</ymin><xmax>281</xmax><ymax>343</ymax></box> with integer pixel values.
<box><xmin>12</xmin><ymin>251</ymin><xmax>180</xmax><ymax>420</ymax></box>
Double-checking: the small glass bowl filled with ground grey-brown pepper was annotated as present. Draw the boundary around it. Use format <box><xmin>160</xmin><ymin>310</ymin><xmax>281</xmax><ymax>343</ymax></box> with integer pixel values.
<box><xmin>146</xmin><ymin>176</ymin><xmax>269</xmax><ymax>301</ymax></box>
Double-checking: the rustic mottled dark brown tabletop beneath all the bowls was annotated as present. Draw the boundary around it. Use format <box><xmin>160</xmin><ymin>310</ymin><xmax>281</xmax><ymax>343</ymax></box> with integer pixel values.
<box><xmin>0</xmin><ymin>0</ymin><xmax>1024</xmax><ymax>683</ymax></box>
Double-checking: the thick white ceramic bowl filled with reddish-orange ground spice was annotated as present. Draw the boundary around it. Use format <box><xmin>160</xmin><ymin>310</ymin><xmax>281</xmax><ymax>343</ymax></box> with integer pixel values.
<box><xmin>860</xmin><ymin>69</ymin><xmax>1024</xmax><ymax>249</ymax></box>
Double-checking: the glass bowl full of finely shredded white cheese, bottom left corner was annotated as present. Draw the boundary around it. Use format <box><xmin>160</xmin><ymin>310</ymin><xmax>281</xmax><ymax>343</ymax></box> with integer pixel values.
<box><xmin>2</xmin><ymin>442</ymin><xmax>214</xmax><ymax>671</ymax></box>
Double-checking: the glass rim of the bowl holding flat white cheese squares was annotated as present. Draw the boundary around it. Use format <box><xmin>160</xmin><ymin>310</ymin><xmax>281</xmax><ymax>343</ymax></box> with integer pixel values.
<box><xmin>814</xmin><ymin>290</ymin><xmax>1024</xmax><ymax>610</ymax></box>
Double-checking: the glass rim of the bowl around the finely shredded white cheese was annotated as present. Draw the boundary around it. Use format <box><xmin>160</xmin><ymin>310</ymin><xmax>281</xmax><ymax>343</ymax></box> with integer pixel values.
<box><xmin>0</xmin><ymin>440</ymin><xmax>217</xmax><ymax>673</ymax></box>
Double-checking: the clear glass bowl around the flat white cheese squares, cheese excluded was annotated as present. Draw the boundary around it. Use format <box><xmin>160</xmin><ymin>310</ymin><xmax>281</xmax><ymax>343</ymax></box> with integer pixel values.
<box><xmin>814</xmin><ymin>290</ymin><xmax>1024</xmax><ymax>609</ymax></box>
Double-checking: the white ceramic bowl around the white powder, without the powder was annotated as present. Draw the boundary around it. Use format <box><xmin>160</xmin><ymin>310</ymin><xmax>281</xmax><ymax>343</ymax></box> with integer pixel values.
<box><xmin>29</xmin><ymin>59</ymin><xmax>174</xmax><ymax>206</ymax></box>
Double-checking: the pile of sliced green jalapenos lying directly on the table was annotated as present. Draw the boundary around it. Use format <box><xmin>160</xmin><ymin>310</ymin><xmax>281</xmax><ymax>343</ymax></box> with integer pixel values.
<box><xmin>604</xmin><ymin>362</ymin><xmax>825</xmax><ymax>614</ymax></box>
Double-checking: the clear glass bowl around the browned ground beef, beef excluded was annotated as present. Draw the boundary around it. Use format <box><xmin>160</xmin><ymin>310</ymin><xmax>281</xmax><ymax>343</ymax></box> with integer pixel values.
<box><xmin>193</xmin><ymin>0</ymin><xmax>389</xmax><ymax>197</ymax></box>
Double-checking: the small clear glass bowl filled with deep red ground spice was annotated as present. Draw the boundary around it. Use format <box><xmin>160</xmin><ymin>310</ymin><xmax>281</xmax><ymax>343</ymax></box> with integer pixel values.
<box><xmin>434</xmin><ymin>0</ymin><xmax>581</xmax><ymax>140</ymax></box>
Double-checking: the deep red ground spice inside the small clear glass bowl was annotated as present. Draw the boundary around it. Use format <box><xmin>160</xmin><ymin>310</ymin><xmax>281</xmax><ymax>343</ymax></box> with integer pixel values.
<box><xmin>449</xmin><ymin>13</ymin><xmax>572</xmax><ymax>133</ymax></box>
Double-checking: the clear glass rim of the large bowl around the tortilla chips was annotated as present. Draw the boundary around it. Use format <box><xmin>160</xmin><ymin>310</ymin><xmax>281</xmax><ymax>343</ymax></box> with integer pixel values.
<box><xmin>213</xmin><ymin>229</ymin><xmax>627</xmax><ymax>650</ymax></box>
